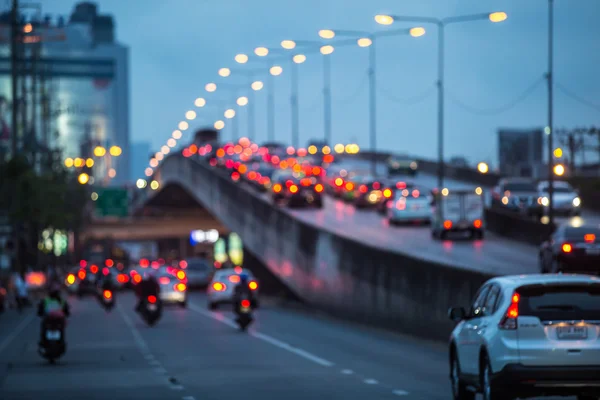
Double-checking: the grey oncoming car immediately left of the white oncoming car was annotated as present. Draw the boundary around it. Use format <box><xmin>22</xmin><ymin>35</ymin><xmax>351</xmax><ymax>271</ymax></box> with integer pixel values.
<box><xmin>492</xmin><ymin>178</ymin><xmax>540</xmax><ymax>215</ymax></box>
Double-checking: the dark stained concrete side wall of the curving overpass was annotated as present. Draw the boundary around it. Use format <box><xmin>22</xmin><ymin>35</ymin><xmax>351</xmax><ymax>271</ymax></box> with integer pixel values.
<box><xmin>157</xmin><ymin>155</ymin><xmax>490</xmax><ymax>340</ymax></box>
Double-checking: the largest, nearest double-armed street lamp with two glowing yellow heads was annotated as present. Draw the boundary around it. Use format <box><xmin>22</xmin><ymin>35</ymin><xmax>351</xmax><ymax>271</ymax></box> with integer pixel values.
<box><xmin>375</xmin><ymin>12</ymin><xmax>507</xmax><ymax>188</ymax></box>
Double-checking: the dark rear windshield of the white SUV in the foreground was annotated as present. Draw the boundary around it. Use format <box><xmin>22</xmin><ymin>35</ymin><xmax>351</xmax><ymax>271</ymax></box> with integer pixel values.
<box><xmin>517</xmin><ymin>283</ymin><xmax>600</xmax><ymax>321</ymax></box>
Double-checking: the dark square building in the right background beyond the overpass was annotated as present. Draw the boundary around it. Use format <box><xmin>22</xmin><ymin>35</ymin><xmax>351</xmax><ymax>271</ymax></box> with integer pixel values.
<box><xmin>498</xmin><ymin>129</ymin><xmax>545</xmax><ymax>179</ymax></box>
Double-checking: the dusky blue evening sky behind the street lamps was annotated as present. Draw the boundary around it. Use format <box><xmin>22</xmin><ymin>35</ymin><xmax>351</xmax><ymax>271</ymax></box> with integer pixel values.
<box><xmin>43</xmin><ymin>0</ymin><xmax>600</xmax><ymax>176</ymax></box>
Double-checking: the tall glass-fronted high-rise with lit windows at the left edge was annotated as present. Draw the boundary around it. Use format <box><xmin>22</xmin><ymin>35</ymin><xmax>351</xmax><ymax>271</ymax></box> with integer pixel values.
<box><xmin>0</xmin><ymin>2</ymin><xmax>131</xmax><ymax>184</ymax></box>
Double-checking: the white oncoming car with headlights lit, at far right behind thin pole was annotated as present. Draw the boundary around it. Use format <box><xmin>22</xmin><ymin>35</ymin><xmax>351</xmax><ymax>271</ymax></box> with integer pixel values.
<box><xmin>537</xmin><ymin>181</ymin><xmax>581</xmax><ymax>217</ymax></box>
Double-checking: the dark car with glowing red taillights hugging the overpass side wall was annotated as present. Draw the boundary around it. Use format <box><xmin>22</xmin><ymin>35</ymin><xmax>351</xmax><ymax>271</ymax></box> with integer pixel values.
<box><xmin>271</xmin><ymin>171</ymin><xmax>325</xmax><ymax>208</ymax></box>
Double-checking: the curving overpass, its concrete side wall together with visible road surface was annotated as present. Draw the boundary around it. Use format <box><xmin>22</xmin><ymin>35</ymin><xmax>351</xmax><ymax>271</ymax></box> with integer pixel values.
<box><xmin>132</xmin><ymin>154</ymin><xmax>537</xmax><ymax>337</ymax></box>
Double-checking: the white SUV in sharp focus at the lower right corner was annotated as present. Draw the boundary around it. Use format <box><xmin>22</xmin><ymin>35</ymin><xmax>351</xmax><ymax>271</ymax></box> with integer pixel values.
<box><xmin>449</xmin><ymin>274</ymin><xmax>600</xmax><ymax>400</ymax></box>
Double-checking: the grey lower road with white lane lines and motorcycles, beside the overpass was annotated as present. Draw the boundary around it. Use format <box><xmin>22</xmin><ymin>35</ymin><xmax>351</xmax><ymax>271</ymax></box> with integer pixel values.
<box><xmin>0</xmin><ymin>293</ymin><xmax>576</xmax><ymax>400</ymax></box>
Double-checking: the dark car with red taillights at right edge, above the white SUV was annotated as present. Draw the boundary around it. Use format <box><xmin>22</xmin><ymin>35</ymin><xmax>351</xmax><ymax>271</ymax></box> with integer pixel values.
<box><xmin>539</xmin><ymin>224</ymin><xmax>600</xmax><ymax>274</ymax></box>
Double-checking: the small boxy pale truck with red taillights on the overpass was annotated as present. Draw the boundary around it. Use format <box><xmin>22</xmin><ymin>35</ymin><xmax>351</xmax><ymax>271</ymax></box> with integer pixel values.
<box><xmin>431</xmin><ymin>188</ymin><xmax>485</xmax><ymax>240</ymax></box>
